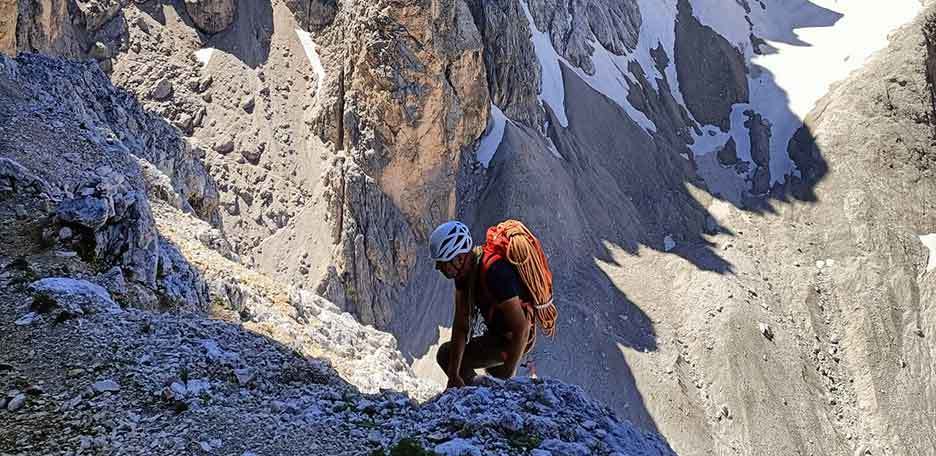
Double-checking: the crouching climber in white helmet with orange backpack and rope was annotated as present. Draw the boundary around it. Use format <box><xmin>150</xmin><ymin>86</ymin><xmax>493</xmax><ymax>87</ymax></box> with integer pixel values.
<box><xmin>429</xmin><ymin>220</ymin><xmax>556</xmax><ymax>388</ymax></box>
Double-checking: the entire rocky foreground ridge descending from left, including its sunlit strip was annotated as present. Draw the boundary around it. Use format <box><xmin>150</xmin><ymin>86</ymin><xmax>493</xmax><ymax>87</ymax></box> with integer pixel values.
<box><xmin>0</xmin><ymin>48</ymin><xmax>673</xmax><ymax>456</ymax></box>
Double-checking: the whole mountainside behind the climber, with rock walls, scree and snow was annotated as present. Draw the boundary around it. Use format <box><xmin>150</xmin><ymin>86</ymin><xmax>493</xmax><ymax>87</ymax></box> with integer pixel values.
<box><xmin>0</xmin><ymin>0</ymin><xmax>936</xmax><ymax>454</ymax></box>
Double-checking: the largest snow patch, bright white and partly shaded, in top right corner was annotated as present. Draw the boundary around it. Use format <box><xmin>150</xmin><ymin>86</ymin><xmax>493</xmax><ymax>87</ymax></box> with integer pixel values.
<box><xmin>688</xmin><ymin>0</ymin><xmax>921</xmax><ymax>185</ymax></box>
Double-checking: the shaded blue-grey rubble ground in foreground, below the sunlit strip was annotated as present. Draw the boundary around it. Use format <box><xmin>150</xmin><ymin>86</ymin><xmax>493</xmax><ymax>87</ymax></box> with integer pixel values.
<box><xmin>0</xmin><ymin>197</ymin><xmax>673</xmax><ymax>455</ymax></box>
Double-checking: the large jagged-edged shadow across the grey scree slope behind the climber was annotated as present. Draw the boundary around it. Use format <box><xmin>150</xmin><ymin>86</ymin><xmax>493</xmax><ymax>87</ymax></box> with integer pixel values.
<box><xmin>395</xmin><ymin>2</ymin><xmax>841</xmax><ymax>442</ymax></box>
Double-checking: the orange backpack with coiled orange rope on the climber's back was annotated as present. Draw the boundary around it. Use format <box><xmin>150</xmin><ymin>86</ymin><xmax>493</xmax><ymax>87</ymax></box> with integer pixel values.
<box><xmin>481</xmin><ymin>220</ymin><xmax>559</xmax><ymax>337</ymax></box>
